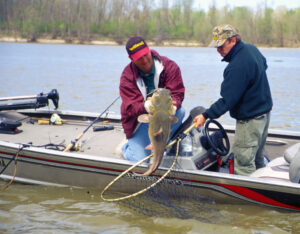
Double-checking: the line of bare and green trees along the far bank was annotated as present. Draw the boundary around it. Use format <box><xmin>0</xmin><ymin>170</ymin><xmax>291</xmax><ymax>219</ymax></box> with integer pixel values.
<box><xmin>0</xmin><ymin>0</ymin><xmax>300</xmax><ymax>47</ymax></box>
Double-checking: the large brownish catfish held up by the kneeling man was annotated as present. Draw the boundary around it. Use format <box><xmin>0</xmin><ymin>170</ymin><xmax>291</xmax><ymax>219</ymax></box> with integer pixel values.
<box><xmin>138</xmin><ymin>88</ymin><xmax>177</xmax><ymax>176</ymax></box>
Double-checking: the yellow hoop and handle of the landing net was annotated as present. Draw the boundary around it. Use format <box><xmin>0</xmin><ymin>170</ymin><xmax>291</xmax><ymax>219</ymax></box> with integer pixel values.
<box><xmin>101</xmin><ymin>124</ymin><xmax>195</xmax><ymax>202</ymax></box>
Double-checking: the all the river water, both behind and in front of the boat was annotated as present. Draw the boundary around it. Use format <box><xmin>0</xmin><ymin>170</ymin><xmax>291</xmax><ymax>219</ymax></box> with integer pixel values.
<box><xmin>0</xmin><ymin>43</ymin><xmax>300</xmax><ymax>233</ymax></box>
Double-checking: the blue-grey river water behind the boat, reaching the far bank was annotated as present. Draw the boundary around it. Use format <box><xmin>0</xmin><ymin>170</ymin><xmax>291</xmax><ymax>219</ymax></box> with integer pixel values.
<box><xmin>0</xmin><ymin>43</ymin><xmax>300</xmax><ymax>131</ymax></box>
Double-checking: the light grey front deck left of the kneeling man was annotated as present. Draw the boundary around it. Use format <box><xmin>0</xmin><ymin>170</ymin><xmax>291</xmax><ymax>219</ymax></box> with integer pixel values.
<box><xmin>0</xmin><ymin>112</ymin><xmax>125</xmax><ymax>158</ymax></box>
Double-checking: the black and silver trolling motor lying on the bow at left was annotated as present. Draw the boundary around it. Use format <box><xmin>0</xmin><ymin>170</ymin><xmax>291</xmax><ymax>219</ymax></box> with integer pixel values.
<box><xmin>0</xmin><ymin>89</ymin><xmax>59</xmax><ymax>111</ymax></box>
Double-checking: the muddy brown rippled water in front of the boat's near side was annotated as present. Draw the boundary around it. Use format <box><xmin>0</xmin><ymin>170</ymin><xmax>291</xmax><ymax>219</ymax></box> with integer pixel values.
<box><xmin>0</xmin><ymin>182</ymin><xmax>300</xmax><ymax>233</ymax></box>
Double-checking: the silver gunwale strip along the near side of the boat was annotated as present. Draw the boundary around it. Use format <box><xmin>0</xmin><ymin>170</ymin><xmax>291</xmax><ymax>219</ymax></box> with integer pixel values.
<box><xmin>0</xmin><ymin>141</ymin><xmax>300</xmax><ymax>195</ymax></box>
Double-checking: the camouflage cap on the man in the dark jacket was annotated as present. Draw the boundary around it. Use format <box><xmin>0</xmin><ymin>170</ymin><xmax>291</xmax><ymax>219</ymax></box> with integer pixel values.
<box><xmin>208</xmin><ymin>24</ymin><xmax>238</xmax><ymax>48</ymax></box>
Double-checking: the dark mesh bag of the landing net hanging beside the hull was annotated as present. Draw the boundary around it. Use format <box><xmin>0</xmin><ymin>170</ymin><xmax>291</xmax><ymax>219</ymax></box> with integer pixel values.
<box><xmin>104</xmin><ymin>147</ymin><xmax>222</xmax><ymax>220</ymax></box>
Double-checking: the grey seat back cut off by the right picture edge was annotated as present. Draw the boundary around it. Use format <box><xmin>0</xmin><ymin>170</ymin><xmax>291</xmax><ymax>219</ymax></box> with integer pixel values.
<box><xmin>289</xmin><ymin>143</ymin><xmax>300</xmax><ymax>184</ymax></box>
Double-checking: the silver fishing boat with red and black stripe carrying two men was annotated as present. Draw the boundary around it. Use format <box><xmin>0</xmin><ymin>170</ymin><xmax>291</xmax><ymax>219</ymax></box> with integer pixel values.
<box><xmin>0</xmin><ymin>90</ymin><xmax>300</xmax><ymax>211</ymax></box>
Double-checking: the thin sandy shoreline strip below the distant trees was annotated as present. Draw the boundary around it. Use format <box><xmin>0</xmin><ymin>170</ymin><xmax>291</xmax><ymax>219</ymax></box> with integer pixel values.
<box><xmin>0</xmin><ymin>36</ymin><xmax>299</xmax><ymax>49</ymax></box>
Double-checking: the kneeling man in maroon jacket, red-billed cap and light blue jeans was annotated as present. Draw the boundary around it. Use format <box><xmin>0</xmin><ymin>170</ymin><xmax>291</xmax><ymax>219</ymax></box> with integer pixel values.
<box><xmin>119</xmin><ymin>36</ymin><xmax>185</xmax><ymax>162</ymax></box>
